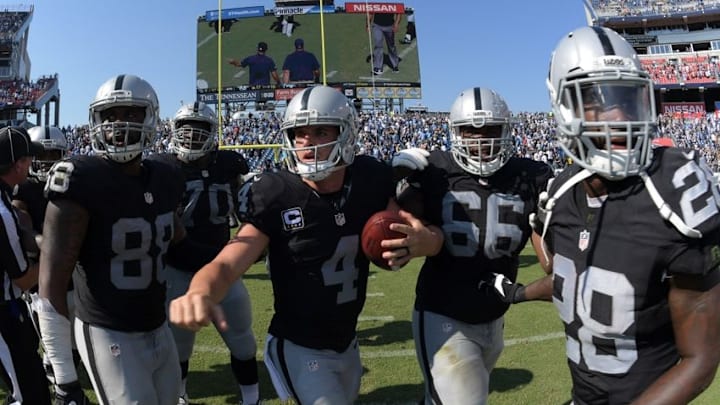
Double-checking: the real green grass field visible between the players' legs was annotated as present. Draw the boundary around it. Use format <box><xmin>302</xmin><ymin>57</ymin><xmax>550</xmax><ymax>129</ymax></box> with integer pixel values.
<box><xmin>2</xmin><ymin>248</ymin><xmax>720</xmax><ymax>405</ymax></box>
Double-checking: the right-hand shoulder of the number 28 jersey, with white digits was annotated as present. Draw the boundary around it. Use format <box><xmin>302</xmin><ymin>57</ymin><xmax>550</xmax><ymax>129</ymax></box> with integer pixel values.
<box><xmin>647</xmin><ymin>148</ymin><xmax>720</xmax><ymax>235</ymax></box>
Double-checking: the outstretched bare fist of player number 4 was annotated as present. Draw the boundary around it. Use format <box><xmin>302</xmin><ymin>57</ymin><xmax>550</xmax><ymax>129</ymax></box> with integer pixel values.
<box><xmin>168</xmin><ymin>292</ymin><xmax>228</xmax><ymax>332</ymax></box>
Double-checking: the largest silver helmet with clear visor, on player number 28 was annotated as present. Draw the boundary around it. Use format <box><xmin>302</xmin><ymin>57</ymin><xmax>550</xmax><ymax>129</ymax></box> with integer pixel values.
<box><xmin>547</xmin><ymin>27</ymin><xmax>657</xmax><ymax>180</ymax></box>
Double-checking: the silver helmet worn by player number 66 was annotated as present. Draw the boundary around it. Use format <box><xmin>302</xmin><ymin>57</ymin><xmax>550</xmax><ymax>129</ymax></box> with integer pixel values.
<box><xmin>450</xmin><ymin>87</ymin><xmax>513</xmax><ymax>177</ymax></box>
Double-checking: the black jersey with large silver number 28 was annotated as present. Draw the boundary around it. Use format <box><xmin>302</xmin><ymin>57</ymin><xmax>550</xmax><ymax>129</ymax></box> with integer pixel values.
<box><xmin>546</xmin><ymin>148</ymin><xmax>720</xmax><ymax>404</ymax></box>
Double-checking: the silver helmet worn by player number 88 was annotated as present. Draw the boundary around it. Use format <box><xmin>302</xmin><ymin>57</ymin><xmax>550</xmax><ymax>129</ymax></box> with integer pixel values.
<box><xmin>90</xmin><ymin>75</ymin><xmax>159</xmax><ymax>163</ymax></box>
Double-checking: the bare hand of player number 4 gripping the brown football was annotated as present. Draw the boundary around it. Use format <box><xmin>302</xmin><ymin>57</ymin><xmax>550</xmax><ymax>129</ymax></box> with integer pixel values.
<box><xmin>381</xmin><ymin>210</ymin><xmax>444</xmax><ymax>268</ymax></box>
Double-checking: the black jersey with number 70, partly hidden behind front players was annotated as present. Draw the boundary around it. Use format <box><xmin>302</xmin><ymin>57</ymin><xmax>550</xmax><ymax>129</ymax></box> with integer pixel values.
<box><xmin>151</xmin><ymin>150</ymin><xmax>248</xmax><ymax>251</ymax></box>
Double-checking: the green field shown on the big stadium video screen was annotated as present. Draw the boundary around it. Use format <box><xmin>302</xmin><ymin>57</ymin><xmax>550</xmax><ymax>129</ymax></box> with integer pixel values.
<box><xmin>197</xmin><ymin>13</ymin><xmax>420</xmax><ymax>89</ymax></box>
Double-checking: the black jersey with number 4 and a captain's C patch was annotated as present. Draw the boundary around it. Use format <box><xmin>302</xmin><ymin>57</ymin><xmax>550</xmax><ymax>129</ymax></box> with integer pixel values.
<box><xmin>238</xmin><ymin>155</ymin><xmax>395</xmax><ymax>351</ymax></box>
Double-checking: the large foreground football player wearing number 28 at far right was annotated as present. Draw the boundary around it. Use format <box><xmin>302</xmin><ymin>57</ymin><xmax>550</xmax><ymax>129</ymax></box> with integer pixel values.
<box><xmin>496</xmin><ymin>27</ymin><xmax>720</xmax><ymax>405</ymax></box>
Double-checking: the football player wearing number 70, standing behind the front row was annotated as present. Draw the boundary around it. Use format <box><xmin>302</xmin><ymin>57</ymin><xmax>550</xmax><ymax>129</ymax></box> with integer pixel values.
<box><xmin>155</xmin><ymin>102</ymin><xmax>259</xmax><ymax>405</ymax></box>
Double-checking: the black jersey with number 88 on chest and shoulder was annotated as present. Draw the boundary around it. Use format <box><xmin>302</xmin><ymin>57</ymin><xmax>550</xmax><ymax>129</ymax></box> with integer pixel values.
<box><xmin>45</xmin><ymin>156</ymin><xmax>183</xmax><ymax>331</ymax></box>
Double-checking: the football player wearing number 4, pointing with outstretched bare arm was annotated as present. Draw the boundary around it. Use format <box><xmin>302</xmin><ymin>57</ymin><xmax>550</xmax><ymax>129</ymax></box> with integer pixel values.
<box><xmin>170</xmin><ymin>86</ymin><xmax>438</xmax><ymax>404</ymax></box>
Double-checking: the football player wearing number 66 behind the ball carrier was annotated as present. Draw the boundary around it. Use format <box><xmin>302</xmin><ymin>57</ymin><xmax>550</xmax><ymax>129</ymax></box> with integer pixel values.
<box><xmin>383</xmin><ymin>87</ymin><xmax>552</xmax><ymax>405</ymax></box>
